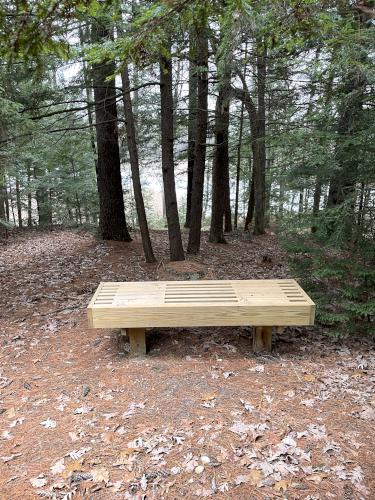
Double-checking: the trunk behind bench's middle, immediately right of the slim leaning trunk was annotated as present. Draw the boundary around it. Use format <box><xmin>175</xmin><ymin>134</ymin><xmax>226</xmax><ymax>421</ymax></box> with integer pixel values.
<box><xmin>160</xmin><ymin>46</ymin><xmax>185</xmax><ymax>261</ymax></box>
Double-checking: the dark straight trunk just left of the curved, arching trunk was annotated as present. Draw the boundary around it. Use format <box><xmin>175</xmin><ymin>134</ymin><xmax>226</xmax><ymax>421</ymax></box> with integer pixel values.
<box><xmin>209</xmin><ymin>75</ymin><xmax>230</xmax><ymax>243</ymax></box>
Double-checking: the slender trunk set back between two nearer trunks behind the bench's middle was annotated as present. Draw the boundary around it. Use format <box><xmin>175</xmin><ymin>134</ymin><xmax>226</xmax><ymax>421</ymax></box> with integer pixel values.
<box><xmin>185</xmin><ymin>35</ymin><xmax>198</xmax><ymax>227</ymax></box>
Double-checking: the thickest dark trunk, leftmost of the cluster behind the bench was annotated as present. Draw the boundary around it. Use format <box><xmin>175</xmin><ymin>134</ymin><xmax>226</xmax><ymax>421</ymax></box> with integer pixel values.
<box><xmin>92</xmin><ymin>18</ymin><xmax>131</xmax><ymax>241</ymax></box>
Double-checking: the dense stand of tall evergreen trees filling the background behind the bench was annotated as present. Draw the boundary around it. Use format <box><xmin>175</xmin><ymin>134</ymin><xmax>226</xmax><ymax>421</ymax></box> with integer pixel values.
<box><xmin>0</xmin><ymin>0</ymin><xmax>375</xmax><ymax>262</ymax></box>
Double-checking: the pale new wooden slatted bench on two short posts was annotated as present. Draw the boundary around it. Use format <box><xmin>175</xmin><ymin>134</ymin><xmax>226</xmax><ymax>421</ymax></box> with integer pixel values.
<box><xmin>87</xmin><ymin>279</ymin><xmax>315</xmax><ymax>354</ymax></box>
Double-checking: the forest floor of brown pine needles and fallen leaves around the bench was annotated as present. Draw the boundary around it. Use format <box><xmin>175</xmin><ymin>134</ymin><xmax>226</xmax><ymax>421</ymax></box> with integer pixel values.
<box><xmin>0</xmin><ymin>230</ymin><xmax>375</xmax><ymax>500</ymax></box>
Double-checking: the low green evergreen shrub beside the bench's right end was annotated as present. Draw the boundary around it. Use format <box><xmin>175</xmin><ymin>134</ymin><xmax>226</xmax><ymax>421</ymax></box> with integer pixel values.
<box><xmin>281</xmin><ymin>231</ymin><xmax>375</xmax><ymax>337</ymax></box>
